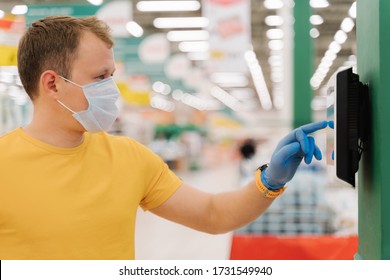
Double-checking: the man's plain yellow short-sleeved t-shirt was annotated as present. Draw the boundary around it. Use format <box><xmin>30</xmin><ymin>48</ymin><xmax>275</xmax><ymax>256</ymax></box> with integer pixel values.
<box><xmin>0</xmin><ymin>128</ymin><xmax>181</xmax><ymax>260</ymax></box>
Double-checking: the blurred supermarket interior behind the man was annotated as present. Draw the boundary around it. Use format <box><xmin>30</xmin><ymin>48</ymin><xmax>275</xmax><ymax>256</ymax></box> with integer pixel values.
<box><xmin>0</xmin><ymin>0</ymin><xmax>357</xmax><ymax>259</ymax></box>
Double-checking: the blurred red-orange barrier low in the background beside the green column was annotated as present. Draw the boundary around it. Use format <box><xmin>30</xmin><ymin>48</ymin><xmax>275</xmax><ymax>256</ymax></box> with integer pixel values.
<box><xmin>230</xmin><ymin>235</ymin><xmax>358</xmax><ymax>260</ymax></box>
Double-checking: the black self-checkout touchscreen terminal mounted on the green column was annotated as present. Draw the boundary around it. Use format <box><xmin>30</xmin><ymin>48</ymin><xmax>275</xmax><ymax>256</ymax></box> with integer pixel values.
<box><xmin>327</xmin><ymin>68</ymin><xmax>371</xmax><ymax>187</ymax></box>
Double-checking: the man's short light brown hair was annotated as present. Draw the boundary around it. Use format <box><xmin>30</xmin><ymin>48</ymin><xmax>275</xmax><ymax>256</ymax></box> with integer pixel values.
<box><xmin>18</xmin><ymin>16</ymin><xmax>113</xmax><ymax>100</ymax></box>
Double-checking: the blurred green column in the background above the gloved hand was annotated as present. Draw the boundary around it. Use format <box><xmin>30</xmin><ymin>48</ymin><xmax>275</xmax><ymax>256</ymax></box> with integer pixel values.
<box><xmin>293</xmin><ymin>0</ymin><xmax>314</xmax><ymax>127</ymax></box>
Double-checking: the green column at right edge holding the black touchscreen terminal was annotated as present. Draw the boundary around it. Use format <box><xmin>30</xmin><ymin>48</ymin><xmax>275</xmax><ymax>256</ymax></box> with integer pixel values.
<box><xmin>355</xmin><ymin>0</ymin><xmax>390</xmax><ymax>259</ymax></box>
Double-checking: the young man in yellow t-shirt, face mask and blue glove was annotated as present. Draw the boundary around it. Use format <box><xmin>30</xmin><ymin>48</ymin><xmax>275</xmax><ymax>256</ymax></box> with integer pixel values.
<box><xmin>0</xmin><ymin>17</ymin><xmax>327</xmax><ymax>259</ymax></box>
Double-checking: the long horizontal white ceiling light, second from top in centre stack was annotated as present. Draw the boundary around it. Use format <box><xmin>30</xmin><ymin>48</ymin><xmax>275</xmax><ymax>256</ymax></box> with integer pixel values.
<box><xmin>153</xmin><ymin>17</ymin><xmax>209</xmax><ymax>28</ymax></box>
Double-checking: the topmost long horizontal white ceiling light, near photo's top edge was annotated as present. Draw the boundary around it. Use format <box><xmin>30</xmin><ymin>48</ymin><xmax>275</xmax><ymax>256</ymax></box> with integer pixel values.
<box><xmin>137</xmin><ymin>1</ymin><xmax>200</xmax><ymax>12</ymax></box>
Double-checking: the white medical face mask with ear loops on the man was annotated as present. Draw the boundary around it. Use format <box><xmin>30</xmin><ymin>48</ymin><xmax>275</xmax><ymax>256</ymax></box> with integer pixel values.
<box><xmin>57</xmin><ymin>76</ymin><xmax>120</xmax><ymax>132</ymax></box>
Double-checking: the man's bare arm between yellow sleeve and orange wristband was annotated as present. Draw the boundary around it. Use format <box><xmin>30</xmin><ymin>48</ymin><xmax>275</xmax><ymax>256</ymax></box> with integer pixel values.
<box><xmin>151</xmin><ymin>181</ymin><xmax>274</xmax><ymax>234</ymax></box>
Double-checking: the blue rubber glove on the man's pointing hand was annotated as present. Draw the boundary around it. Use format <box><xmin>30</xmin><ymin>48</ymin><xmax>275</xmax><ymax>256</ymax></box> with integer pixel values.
<box><xmin>261</xmin><ymin>121</ymin><xmax>328</xmax><ymax>190</ymax></box>
